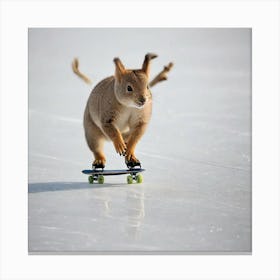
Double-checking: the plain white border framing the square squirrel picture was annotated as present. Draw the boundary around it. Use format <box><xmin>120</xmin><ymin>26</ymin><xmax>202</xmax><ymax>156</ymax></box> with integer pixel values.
<box><xmin>0</xmin><ymin>0</ymin><xmax>280</xmax><ymax>280</ymax></box>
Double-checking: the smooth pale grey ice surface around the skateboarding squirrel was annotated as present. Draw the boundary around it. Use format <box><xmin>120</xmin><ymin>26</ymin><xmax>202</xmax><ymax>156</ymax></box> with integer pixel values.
<box><xmin>28</xmin><ymin>29</ymin><xmax>251</xmax><ymax>253</ymax></box>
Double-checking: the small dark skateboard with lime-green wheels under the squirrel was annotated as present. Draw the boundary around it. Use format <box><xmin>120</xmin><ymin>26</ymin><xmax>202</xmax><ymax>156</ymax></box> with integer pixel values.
<box><xmin>82</xmin><ymin>168</ymin><xmax>145</xmax><ymax>184</ymax></box>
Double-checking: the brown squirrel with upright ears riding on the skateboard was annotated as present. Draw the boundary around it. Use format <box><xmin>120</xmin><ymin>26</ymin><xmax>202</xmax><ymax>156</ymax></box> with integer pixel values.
<box><xmin>72</xmin><ymin>53</ymin><xmax>173</xmax><ymax>168</ymax></box>
